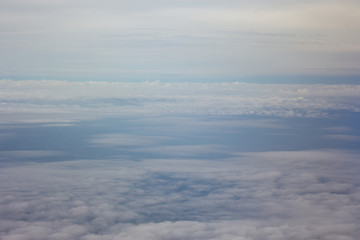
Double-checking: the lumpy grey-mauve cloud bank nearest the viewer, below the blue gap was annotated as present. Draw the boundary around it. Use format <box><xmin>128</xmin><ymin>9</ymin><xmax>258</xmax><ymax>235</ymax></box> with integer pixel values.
<box><xmin>0</xmin><ymin>150</ymin><xmax>360</xmax><ymax>240</ymax></box>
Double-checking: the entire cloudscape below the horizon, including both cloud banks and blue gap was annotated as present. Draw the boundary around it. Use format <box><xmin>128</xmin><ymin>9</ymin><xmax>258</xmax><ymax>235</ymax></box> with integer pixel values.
<box><xmin>0</xmin><ymin>80</ymin><xmax>360</xmax><ymax>240</ymax></box>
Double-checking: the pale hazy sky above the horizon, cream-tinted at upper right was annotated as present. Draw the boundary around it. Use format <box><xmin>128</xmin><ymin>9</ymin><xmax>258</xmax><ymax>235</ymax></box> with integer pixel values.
<box><xmin>0</xmin><ymin>0</ymin><xmax>360</xmax><ymax>80</ymax></box>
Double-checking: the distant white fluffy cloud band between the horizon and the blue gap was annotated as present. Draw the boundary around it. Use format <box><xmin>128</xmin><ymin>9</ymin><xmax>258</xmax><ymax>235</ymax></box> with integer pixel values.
<box><xmin>0</xmin><ymin>80</ymin><xmax>360</xmax><ymax>124</ymax></box>
